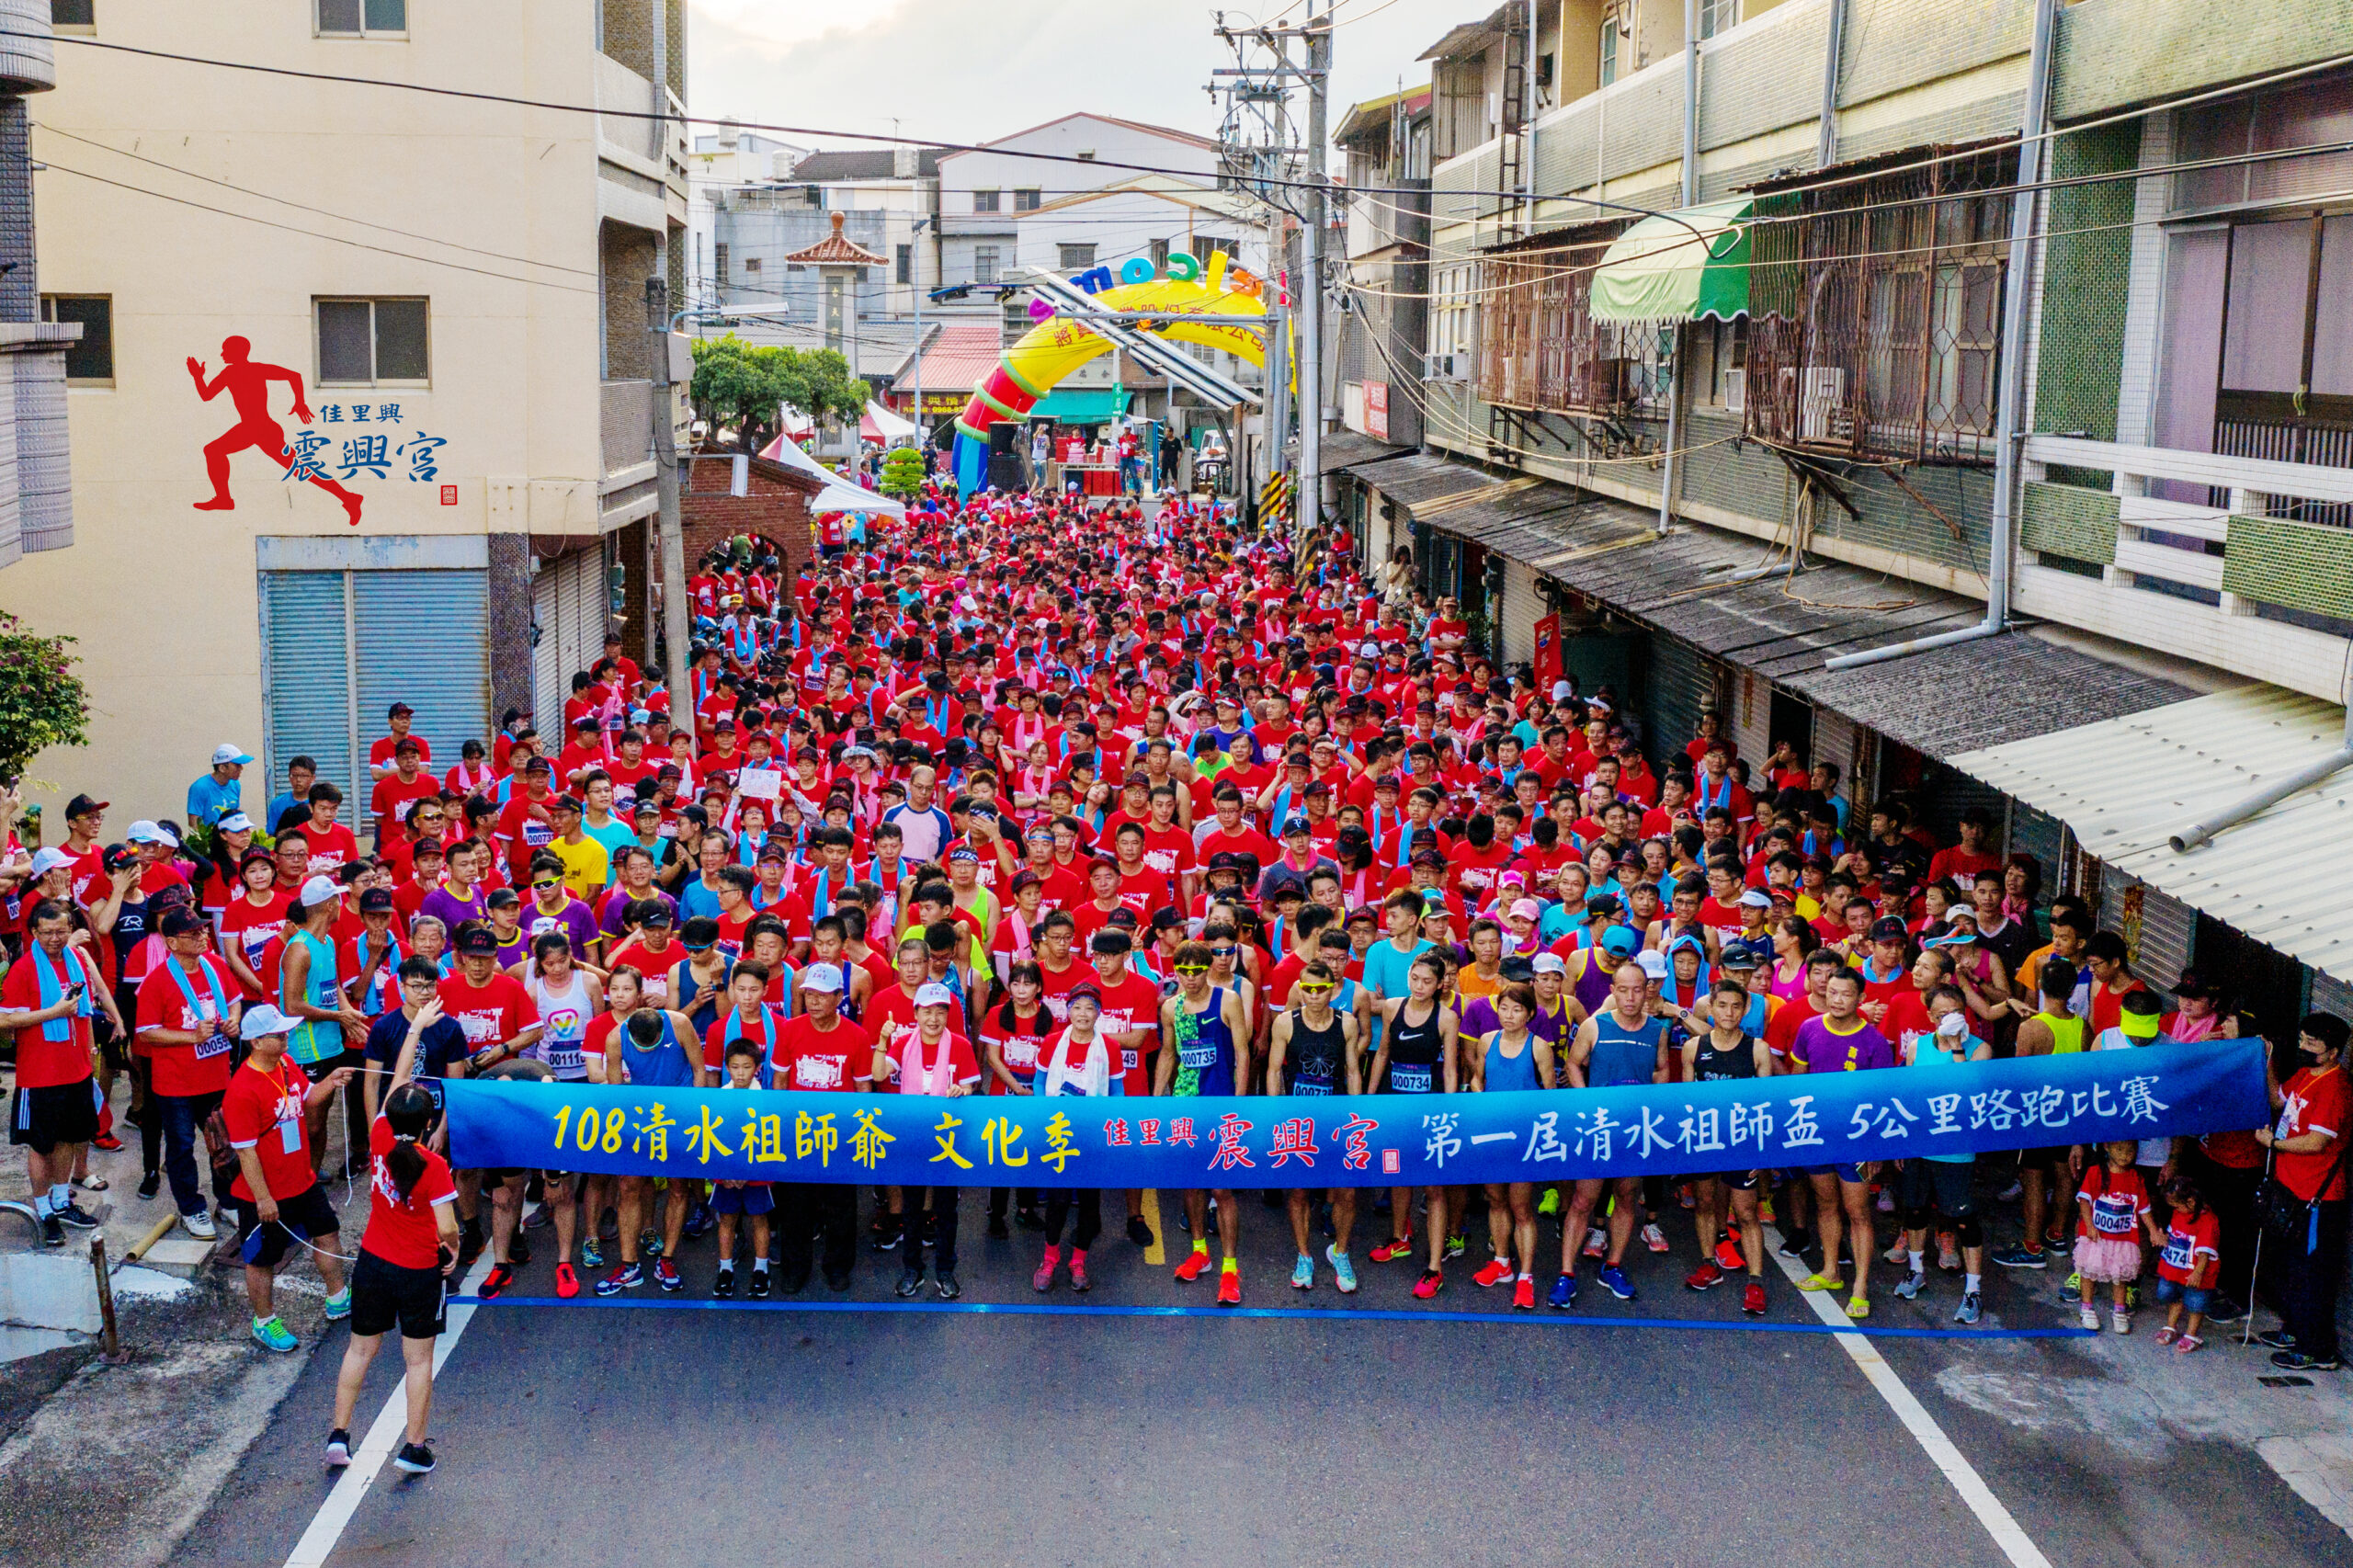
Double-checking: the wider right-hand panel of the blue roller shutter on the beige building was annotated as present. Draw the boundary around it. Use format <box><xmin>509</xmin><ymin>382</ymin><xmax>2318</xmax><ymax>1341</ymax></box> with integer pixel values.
<box><xmin>350</xmin><ymin>572</ymin><xmax>489</xmax><ymax>772</ymax></box>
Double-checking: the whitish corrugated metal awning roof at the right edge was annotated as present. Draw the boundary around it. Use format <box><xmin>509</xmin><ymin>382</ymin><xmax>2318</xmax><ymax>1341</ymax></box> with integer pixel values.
<box><xmin>1953</xmin><ymin>685</ymin><xmax>2353</xmax><ymax>980</ymax></box>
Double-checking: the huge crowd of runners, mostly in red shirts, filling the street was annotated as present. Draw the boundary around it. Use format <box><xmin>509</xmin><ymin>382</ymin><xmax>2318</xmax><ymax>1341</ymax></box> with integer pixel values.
<box><xmin>0</xmin><ymin>472</ymin><xmax>2348</xmax><ymax>1464</ymax></box>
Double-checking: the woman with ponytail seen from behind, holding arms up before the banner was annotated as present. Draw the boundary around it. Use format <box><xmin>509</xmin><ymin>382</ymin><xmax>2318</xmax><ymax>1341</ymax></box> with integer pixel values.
<box><xmin>327</xmin><ymin>1050</ymin><xmax>457</xmax><ymax>1476</ymax></box>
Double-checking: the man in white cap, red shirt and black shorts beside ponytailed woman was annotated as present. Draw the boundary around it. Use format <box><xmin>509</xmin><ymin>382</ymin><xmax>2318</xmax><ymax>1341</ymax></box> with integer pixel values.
<box><xmin>222</xmin><ymin>1003</ymin><xmax>353</xmax><ymax>1351</ymax></box>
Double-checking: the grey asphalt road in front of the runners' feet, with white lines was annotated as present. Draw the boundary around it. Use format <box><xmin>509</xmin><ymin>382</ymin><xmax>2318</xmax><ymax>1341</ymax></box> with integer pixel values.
<box><xmin>161</xmin><ymin>1194</ymin><xmax>2353</xmax><ymax>1568</ymax></box>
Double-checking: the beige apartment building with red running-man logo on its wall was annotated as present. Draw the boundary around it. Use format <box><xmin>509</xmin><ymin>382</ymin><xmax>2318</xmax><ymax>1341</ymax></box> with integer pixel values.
<box><xmin>0</xmin><ymin>0</ymin><xmax>688</xmax><ymax>822</ymax></box>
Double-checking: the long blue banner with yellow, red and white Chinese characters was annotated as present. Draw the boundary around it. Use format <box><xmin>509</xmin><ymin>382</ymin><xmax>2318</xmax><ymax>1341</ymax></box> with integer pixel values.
<box><xmin>445</xmin><ymin>1040</ymin><xmax>2270</xmax><ymax>1189</ymax></box>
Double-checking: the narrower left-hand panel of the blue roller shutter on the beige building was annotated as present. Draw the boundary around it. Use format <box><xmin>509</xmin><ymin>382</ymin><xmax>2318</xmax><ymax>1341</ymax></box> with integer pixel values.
<box><xmin>259</xmin><ymin>572</ymin><xmax>367</xmax><ymax>826</ymax></box>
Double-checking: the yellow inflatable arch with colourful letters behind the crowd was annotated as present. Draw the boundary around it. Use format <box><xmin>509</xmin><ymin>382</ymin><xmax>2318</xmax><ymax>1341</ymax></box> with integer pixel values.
<box><xmin>955</xmin><ymin>250</ymin><xmax>1266</xmax><ymax>496</ymax></box>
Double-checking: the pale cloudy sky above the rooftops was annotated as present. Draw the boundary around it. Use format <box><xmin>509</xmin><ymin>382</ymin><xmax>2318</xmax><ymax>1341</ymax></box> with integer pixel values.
<box><xmin>689</xmin><ymin>0</ymin><xmax>1449</xmax><ymax>156</ymax></box>
